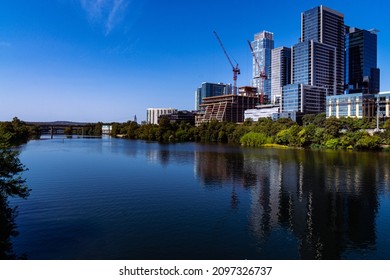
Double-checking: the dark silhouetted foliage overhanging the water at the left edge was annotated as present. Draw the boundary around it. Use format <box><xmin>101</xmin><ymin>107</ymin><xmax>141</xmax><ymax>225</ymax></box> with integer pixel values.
<box><xmin>0</xmin><ymin>147</ymin><xmax>30</xmax><ymax>259</ymax></box>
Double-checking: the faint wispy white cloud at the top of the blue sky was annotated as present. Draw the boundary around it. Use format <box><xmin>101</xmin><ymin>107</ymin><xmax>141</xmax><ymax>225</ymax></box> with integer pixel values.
<box><xmin>80</xmin><ymin>0</ymin><xmax>130</xmax><ymax>35</ymax></box>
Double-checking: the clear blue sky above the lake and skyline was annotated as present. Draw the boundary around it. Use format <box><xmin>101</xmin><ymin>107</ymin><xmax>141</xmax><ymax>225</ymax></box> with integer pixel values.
<box><xmin>0</xmin><ymin>0</ymin><xmax>390</xmax><ymax>122</ymax></box>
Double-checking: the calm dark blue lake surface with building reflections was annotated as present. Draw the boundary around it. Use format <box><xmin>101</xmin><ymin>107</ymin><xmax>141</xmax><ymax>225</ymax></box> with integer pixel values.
<box><xmin>5</xmin><ymin>138</ymin><xmax>390</xmax><ymax>260</ymax></box>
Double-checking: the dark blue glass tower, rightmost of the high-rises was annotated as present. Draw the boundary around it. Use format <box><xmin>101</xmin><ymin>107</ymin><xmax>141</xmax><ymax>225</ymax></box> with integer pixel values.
<box><xmin>345</xmin><ymin>27</ymin><xmax>380</xmax><ymax>93</ymax></box>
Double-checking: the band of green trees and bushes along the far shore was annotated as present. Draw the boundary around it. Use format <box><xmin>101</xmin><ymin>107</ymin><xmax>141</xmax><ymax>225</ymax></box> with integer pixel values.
<box><xmin>0</xmin><ymin>114</ymin><xmax>390</xmax><ymax>151</ymax></box>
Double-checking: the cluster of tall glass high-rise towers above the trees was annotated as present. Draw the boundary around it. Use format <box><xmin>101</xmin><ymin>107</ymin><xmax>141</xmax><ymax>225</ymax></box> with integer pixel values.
<box><xmin>197</xmin><ymin>5</ymin><xmax>380</xmax><ymax>118</ymax></box>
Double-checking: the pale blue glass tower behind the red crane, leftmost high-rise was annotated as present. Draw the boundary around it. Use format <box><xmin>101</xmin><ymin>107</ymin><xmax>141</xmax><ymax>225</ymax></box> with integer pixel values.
<box><xmin>252</xmin><ymin>31</ymin><xmax>274</xmax><ymax>100</ymax></box>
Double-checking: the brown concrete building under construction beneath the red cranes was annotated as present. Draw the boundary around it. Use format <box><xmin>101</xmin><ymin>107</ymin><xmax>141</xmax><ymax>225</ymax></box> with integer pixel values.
<box><xmin>195</xmin><ymin>88</ymin><xmax>259</xmax><ymax>126</ymax></box>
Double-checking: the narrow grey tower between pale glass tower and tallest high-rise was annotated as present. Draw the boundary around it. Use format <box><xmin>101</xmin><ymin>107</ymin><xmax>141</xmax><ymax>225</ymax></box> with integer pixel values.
<box><xmin>271</xmin><ymin>47</ymin><xmax>291</xmax><ymax>104</ymax></box>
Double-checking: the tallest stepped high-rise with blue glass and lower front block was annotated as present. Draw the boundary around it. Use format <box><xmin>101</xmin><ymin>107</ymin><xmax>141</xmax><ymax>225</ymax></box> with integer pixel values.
<box><xmin>281</xmin><ymin>6</ymin><xmax>345</xmax><ymax>113</ymax></box>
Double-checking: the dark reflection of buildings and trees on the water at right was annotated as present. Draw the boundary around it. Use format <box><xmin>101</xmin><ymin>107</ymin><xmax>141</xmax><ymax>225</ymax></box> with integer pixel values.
<box><xmin>196</xmin><ymin>149</ymin><xmax>389</xmax><ymax>259</ymax></box>
